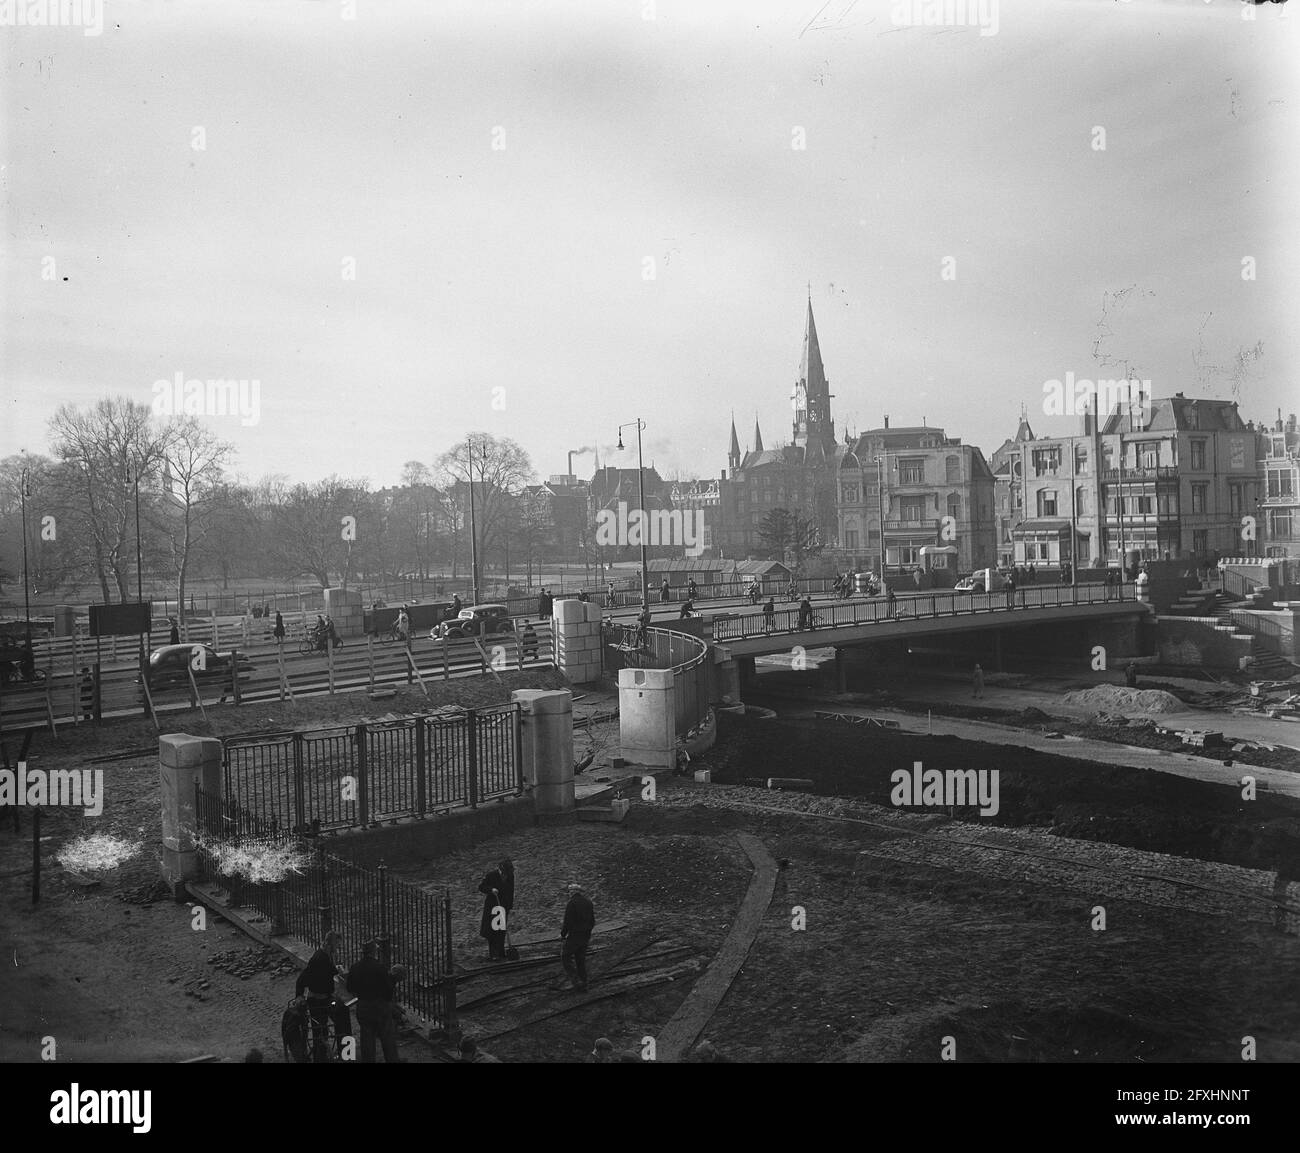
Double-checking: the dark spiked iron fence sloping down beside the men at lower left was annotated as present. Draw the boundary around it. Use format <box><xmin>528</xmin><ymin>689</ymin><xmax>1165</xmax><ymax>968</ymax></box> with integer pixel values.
<box><xmin>194</xmin><ymin>785</ymin><xmax>455</xmax><ymax>1028</ymax></box>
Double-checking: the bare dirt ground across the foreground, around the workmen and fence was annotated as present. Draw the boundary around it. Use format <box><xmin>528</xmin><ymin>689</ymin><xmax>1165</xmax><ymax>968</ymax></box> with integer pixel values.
<box><xmin>0</xmin><ymin>698</ymin><xmax>1300</xmax><ymax>1062</ymax></box>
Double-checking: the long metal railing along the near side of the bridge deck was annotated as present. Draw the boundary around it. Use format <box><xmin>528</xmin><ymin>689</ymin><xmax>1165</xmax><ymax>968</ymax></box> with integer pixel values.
<box><xmin>714</xmin><ymin>584</ymin><xmax>1136</xmax><ymax>643</ymax></box>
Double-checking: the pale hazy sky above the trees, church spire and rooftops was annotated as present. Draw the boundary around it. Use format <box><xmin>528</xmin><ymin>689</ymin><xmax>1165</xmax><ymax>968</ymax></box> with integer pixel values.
<box><xmin>0</xmin><ymin>0</ymin><xmax>1300</xmax><ymax>486</ymax></box>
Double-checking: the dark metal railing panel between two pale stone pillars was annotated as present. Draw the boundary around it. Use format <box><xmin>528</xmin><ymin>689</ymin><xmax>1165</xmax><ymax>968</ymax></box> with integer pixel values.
<box><xmin>222</xmin><ymin>705</ymin><xmax>524</xmax><ymax>832</ymax></box>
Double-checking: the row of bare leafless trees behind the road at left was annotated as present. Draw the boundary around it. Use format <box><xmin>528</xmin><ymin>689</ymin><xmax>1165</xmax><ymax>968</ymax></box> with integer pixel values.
<box><xmin>0</xmin><ymin>396</ymin><xmax>553</xmax><ymax>626</ymax></box>
